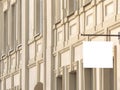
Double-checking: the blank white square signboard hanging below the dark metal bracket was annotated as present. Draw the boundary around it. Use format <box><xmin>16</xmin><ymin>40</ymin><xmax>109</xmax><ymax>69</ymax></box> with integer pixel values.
<box><xmin>83</xmin><ymin>41</ymin><xmax>113</xmax><ymax>68</ymax></box>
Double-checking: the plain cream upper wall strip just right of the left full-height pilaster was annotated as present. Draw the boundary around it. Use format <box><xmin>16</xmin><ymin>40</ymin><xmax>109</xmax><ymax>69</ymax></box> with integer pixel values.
<box><xmin>29</xmin><ymin>0</ymin><xmax>34</xmax><ymax>39</ymax></box>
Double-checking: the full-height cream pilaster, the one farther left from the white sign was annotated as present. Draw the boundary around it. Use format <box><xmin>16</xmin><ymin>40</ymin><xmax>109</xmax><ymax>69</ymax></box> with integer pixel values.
<box><xmin>21</xmin><ymin>0</ymin><xmax>29</xmax><ymax>90</ymax></box>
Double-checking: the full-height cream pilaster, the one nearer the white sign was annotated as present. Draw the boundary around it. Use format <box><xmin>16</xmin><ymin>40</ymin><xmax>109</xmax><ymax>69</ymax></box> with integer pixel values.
<box><xmin>46</xmin><ymin>0</ymin><xmax>53</xmax><ymax>90</ymax></box>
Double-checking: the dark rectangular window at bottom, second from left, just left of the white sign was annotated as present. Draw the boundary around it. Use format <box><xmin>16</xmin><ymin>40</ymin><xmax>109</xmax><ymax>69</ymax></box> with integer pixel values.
<box><xmin>69</xmin><ymin>72</ymin><xmax>77</xmax><ymax>90</ymax></box>
